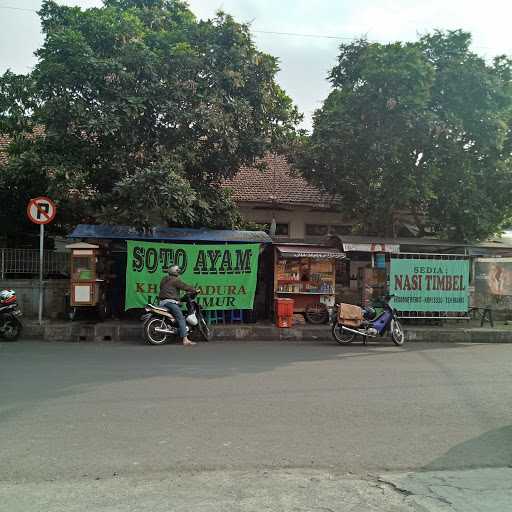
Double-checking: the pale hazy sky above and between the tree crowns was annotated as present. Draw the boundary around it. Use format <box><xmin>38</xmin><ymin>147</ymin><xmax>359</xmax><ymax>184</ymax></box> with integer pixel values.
<box><xmin>0</xmin><ymin>0</ymin><xmax>512</xmax><ymax>129</ymax></box>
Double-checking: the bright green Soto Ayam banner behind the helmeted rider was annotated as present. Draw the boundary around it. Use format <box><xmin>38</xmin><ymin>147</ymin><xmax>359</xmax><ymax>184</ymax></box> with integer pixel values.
<box><xmin>125</xmin><ymin>240</ymin><xmax>260</xmax><ymax>310</ymax></box>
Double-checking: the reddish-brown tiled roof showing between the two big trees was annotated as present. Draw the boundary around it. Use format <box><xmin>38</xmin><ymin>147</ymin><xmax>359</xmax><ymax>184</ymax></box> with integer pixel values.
<box><xmin>224</xmin><ymin>154</ymin><xmax>332</xmax><ymax>207</ymax></box>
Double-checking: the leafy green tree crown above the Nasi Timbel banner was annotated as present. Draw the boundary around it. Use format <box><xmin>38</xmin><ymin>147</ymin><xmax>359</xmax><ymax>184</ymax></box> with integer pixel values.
<box><xmin>291</xmin><ymin>31</ymin><xmax>512</xmax><ymax>240</ymax></box>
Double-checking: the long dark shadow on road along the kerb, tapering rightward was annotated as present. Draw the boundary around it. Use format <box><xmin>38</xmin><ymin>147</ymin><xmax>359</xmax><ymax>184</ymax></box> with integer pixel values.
<box><xmin>0</xmin><ymin>340</ymin><xmax>488</xmax><ymax>421</ymax></box>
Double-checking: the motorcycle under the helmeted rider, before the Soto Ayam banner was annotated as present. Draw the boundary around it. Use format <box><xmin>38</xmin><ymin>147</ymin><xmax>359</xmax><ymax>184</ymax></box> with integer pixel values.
<box><xmin>141</xmin><ymin>293</ymin><xmax>211</xmax><ymax>345</ymax></box>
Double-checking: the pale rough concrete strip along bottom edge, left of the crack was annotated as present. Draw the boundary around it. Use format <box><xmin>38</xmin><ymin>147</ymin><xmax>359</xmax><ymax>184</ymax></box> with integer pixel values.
<box><xmin>0</xmin><ymin>469</ymin><xmax>417</xmax><ymax>512</ymax></box>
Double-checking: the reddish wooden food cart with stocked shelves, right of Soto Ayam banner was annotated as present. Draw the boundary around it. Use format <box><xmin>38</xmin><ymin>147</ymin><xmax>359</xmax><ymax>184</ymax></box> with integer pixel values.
<box><xmin>274</xmin><ymin>244</ymin><xmax>345</xmax><ymax>324</ymax></box>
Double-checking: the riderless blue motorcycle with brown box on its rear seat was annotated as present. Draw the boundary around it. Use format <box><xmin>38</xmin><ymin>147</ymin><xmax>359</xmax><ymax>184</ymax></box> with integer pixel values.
<box><xmin>332</xmin><ymin>295</ymin><xmax>405</xmax><ymax>346</ymax></box>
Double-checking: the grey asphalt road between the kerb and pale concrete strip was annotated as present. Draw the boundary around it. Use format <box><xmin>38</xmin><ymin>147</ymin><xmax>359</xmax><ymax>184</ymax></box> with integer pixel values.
<box><xmin>0</xmin><ymin>342</ymin><xmax>512</xmax><ymax>510</ymax></box>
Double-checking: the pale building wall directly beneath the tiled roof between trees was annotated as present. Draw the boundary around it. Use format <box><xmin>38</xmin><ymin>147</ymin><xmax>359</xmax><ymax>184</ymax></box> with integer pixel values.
<box><xmin>239</xmin><ymin>205</ymin><xmax>346</xmax><ymax>240</ymax></box>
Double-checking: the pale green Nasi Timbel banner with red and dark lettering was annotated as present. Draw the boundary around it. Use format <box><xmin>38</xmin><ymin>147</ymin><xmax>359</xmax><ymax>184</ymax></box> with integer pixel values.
<box><xmin>389</xmin><ymin>258</ymin><xmax>469</xmax><ymax>312</ymax></box>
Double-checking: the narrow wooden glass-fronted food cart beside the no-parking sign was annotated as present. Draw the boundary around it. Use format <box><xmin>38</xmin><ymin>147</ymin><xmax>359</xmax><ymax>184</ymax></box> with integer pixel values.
<box><xmin>66</xmin><ymin>242</ymin><xmax>110</xmax><ymax>320</ymax></box>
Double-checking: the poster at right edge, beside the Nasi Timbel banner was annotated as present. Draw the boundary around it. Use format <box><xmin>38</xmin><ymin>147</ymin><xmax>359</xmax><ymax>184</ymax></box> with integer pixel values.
<box><xmin>474</xmin><ymin>258</ymin><xmax>512</xmax><ymax>309</ymax></box>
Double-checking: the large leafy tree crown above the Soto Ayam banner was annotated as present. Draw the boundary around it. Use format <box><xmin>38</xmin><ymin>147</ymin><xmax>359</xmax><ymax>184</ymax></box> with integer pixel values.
<box><xmin>0</xmin><ymin>0</ymin><xmax>299</xmax><ymax>236</ymax></box>
